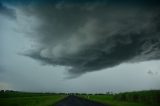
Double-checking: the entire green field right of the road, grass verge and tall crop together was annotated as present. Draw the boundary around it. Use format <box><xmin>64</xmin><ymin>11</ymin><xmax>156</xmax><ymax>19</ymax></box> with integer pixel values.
<box><xmin>81</xmin><ymin>90</ymin><xmax>160</xmax><ymax>106</ymax></box>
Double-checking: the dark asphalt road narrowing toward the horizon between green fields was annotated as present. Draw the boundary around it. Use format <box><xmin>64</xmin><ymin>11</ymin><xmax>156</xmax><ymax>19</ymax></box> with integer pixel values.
<box><xmin>55</xmin><ymin>95</ymin><xmax>108</xmax><ymax>106</ymax></box>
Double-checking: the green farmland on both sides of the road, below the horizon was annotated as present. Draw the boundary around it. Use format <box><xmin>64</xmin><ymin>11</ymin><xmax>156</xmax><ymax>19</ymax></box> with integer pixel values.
<box><xmin>0</xmin><ymin>90</ymin><xmax>160</xmax><ymax>106</ymax></box>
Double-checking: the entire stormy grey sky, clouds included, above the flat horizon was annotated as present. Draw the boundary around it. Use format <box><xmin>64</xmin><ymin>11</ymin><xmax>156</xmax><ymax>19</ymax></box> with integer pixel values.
<box><xmin>0</xmin><ymin>0</ymin><xmax>160</xmax><ymax>93</ymax></box>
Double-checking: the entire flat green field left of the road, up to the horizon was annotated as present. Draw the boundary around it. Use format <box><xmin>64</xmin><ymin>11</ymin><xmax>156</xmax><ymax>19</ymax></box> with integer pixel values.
<box><xmin>0</xmin><ymin>92</ymin><xmax>65</xmax><ymax>106</ymax></box>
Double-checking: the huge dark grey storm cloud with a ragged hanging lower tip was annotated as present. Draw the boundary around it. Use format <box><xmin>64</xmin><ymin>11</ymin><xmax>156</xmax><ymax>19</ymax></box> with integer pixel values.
<box><xmin>18</xmin><ymin>3</ymin><xmax>160</xmax><ymax>76</ymax></box>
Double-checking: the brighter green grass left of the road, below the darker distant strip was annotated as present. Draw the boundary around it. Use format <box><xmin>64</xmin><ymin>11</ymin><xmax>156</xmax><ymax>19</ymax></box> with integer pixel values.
<box><xmin>0</xmin><ymin>95</ymin><xmax>65</xmax><ymax>106</ymax></box>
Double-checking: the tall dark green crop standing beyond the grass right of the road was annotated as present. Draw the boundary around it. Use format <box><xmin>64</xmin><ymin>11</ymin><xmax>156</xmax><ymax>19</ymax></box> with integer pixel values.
<box><xmin>114</xmin><ymin>90</ymin><xmax>160</xmax><ymax>106</ymax></box>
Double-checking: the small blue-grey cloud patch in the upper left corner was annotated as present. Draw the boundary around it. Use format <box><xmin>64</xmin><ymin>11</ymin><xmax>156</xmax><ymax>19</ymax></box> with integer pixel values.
<box><xmin>0</xmin><ymin>1</ymin><xmax>16</xmax><ymax>18</ymax></box>
